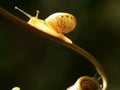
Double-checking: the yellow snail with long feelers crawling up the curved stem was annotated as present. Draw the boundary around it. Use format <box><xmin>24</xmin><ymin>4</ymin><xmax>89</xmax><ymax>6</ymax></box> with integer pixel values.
<box><xmin>15</xmin><ymin>7</ymin><xmax>77</xmax><ymax>44</ymax></box>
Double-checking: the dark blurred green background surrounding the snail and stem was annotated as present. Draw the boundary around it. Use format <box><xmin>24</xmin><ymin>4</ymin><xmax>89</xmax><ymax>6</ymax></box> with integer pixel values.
<box><xmin>0</xmin><ymin>0</ymin><xmax>120</xmax><ymax>90</ymax></box>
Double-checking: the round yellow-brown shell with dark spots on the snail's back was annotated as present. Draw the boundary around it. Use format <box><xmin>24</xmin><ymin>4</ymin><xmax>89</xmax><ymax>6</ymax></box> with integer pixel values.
<box><xmin>45</xmin><ymin>12</ymin><xmax>77</xmax><ymax>34</ymax></box>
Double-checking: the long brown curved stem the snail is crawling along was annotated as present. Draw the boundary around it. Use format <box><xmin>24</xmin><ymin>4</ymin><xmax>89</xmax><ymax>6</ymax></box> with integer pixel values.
<box><xmin>0</xmin><ymin>7</ymin><xmax>107</xmax><ymax>90</ymax></box>
